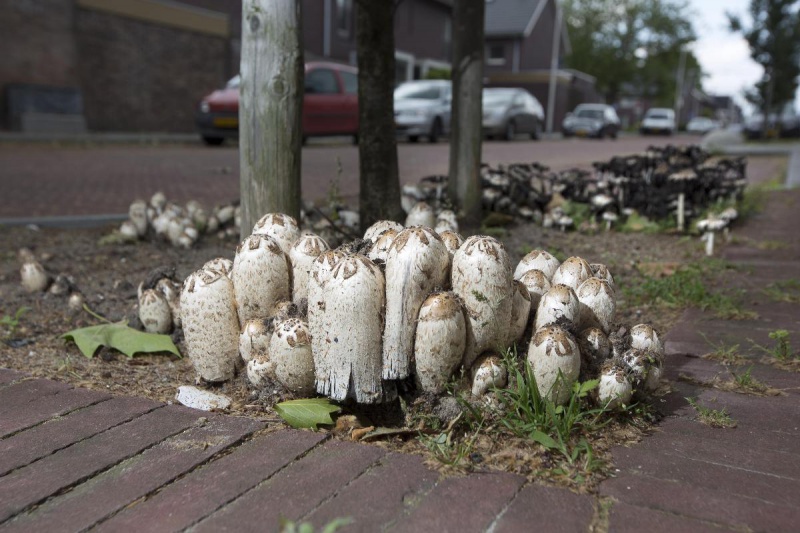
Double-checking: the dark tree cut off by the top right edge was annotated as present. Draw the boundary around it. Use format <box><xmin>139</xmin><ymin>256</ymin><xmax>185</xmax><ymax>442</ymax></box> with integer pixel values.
<box><xmin>728</xmin><ymin>0</ymin><xmax>800</xmax><ymax>129</ymax></box>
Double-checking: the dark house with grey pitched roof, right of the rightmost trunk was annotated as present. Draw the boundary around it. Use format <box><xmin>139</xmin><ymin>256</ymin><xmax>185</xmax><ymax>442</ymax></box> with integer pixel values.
<box><xmin>484</xmin><ymin>0</ymin><xmax>600</xmax><ymax>130</ymax></box>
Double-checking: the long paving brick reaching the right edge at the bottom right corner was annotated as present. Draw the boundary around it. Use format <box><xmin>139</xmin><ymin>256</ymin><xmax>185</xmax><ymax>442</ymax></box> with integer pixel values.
<box><xmin>600</xmin><ymin>475</ymin><xmax>800</xmax><ymax>533</ymax></box>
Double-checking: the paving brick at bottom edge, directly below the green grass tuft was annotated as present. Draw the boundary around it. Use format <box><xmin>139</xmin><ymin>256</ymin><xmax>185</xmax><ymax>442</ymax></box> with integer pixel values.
<box><xmin>492</xmin><ymin>485</ymin><xmax>594</xmax><ymax>533</ymax></box>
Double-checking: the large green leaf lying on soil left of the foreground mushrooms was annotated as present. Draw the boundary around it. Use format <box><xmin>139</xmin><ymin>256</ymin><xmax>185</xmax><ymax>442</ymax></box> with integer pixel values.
<box><xmin>62</xmin><ymin>322</ymin><xmax>181</xmax><ymax>358</ymax></box>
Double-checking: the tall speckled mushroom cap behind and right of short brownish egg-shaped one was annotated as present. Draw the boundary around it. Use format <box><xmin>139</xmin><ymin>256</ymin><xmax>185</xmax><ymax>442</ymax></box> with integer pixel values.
<box><xmin>451</xmin><ymin>235</ymin><xmax>513</xmax><ymax>368</ymax></box>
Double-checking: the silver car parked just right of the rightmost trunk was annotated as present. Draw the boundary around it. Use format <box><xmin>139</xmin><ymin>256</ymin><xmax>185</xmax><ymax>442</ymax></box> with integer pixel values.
<box><xmin>483</xmin><ymin>88</ymin><xmax>544</xmax><ymax>141</ymax></box>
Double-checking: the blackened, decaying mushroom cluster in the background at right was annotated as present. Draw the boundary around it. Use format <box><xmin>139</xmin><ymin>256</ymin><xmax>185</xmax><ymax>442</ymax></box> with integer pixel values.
<box><xmin>403</xmin><ymin>145</ymin><xmax>747</xmax><ymax>230</ymax></box>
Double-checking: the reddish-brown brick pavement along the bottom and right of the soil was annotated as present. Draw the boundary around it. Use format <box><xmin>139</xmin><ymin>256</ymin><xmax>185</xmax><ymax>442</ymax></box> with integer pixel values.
<box><xmin>0</xmin><ymin>148</ymin><xmax>800</xmax><ymax>532</ymax></box>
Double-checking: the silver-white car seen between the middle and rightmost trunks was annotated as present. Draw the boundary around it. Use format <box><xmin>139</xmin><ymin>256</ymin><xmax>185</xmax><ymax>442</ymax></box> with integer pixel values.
<box><xmin>394</xmin><ymin>80</ymin><xmax>452</xmax><ymax>143</ymax></box>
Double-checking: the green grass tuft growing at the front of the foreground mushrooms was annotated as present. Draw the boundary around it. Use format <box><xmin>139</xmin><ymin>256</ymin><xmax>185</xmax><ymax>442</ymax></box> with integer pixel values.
<box><xmin>488</xmin><ymin>351</ymin><xmax>606</xmax><ymax>465</ymax></box>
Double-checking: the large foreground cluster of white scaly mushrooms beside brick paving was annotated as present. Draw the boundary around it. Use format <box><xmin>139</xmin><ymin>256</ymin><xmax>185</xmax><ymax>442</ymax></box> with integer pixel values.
<box><xmin>180</xmin><ymin>212</ymin><xmax>663</xmax><ymax>404</ymax></box>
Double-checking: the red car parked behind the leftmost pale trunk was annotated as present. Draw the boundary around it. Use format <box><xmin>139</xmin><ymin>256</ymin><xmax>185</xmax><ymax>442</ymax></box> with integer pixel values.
<box><xmin>197</xmin><ymin>62</ymin><xmax>358</xmax><ymax>145</ymax></box>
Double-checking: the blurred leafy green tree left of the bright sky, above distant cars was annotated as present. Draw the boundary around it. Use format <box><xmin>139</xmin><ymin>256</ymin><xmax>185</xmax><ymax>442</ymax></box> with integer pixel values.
<box><xmin>563</xmin><ymin>0</ymin><xmax>700</xmax><ymax>107</ymax></box>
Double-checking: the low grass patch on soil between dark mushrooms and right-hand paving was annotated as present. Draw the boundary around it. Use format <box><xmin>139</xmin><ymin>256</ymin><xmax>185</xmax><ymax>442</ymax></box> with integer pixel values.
<box><xmin>622</xmin><ymin>260</ymin><xmax>754</xmax><ymax>320</ymax></box>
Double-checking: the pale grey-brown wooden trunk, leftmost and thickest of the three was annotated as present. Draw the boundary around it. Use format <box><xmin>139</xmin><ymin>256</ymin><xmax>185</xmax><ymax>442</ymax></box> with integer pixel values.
<box><xmin>239</xmin><ymin>0</ymin><xmax>304</xmax><ymax>238</ymax></box>
